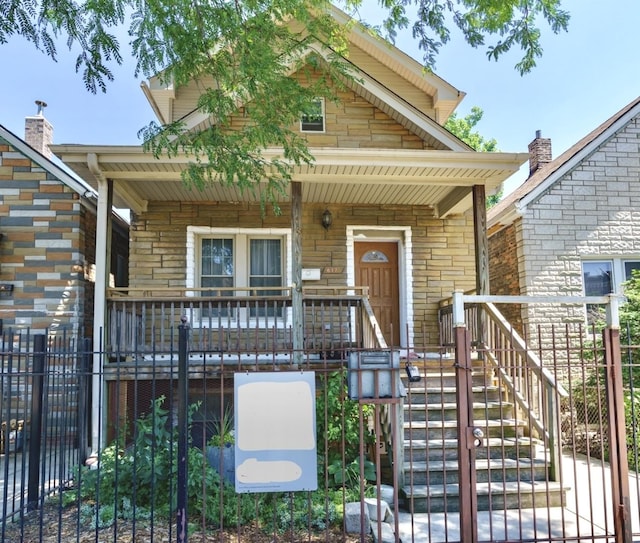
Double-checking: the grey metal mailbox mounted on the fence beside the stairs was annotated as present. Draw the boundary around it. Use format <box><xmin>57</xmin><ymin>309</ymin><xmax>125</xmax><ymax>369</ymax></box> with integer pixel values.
<box><xmin>348</xmin><ymin>351</ymin><xmax>402</xmax><ymax>400</ymax></box>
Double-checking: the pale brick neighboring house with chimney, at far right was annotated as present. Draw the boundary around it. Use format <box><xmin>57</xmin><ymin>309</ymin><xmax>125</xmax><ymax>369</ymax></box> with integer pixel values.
<box><xmin>487</xmin><ymin>98</ymin><xmax>640</xmax><ymax>338</ymax></box>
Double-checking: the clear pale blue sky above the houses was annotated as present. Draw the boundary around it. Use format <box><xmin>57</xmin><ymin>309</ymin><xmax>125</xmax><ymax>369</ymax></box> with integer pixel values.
<box><xmin>0</xmin><ymin>0</ymin><xmax>640</xmax><ymax>193</ymax></box>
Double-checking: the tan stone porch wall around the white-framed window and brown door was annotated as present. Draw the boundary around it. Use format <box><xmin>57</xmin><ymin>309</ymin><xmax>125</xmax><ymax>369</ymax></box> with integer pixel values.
<box><xmin>129</xmin><ymin>202</ymin><xmax>475</xmax><ymax>345</ymax></box>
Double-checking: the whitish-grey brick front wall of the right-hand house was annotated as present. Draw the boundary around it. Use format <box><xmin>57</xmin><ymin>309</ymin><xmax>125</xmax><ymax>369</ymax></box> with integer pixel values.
<box><xmin>518</xmin><ymin>114</ymin><xmax>640</xmax><ymax>341</ymax></box>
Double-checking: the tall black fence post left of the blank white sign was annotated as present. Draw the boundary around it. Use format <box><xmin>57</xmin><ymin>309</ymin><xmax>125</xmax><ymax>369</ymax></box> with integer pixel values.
<box><xmin>176</xmin><ymin>315</ymin><xmax>189</xmax><ymax>543</ymax></box>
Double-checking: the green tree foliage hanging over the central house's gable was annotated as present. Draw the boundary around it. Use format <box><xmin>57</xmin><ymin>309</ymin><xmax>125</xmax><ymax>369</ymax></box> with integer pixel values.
<box><xmin>0</xmin><ymin>0</ymin><xmax>569</xmax><ymax>206</ymax></box>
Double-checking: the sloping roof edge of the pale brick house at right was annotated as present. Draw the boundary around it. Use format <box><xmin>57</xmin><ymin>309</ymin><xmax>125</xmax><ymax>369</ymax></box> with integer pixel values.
<box><xmin>487</xmin><ymin>96</ymin><xmax>640</xmax><ymax>234</ymax></box>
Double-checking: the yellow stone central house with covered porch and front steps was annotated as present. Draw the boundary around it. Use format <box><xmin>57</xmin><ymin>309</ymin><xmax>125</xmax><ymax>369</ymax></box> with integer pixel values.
<box><xmin>12</xmin><ymin>12</ymin><xmax>640</xmax><ymax>541</ymax></box>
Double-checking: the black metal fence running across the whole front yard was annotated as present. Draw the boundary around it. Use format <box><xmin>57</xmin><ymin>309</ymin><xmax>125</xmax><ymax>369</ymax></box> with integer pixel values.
<box><xmin>0</xmin><ymin>328</ymin><xmax>640</xmax><ymax>543</ymax></box>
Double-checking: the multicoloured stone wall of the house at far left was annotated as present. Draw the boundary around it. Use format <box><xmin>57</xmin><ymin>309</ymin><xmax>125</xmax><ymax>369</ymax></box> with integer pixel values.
<box><xmin>0</xmin><ymin>139</ymin><xmax>88</xmax><ymax>331</ymax></box>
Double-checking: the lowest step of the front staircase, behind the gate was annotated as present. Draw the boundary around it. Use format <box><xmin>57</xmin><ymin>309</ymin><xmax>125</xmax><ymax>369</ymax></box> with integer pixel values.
<box><xmin>401</xmin><ymin>481</ymin><xmax>569</xmax><ymax>513</ymax></box>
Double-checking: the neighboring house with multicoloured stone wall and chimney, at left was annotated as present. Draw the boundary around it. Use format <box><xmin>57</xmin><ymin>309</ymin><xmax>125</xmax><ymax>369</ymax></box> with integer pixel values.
<box><xmin>0</xmin><ymin>102</ymin><xmax>129</xmax><ymax>338</ymax></box>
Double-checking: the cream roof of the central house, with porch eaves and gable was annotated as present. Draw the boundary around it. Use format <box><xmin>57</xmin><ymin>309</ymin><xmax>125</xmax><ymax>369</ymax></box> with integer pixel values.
<box><xmin>52</xmin><ymin>5</ymin><xmax>527</xmax><ymax>217</ymax></box>
